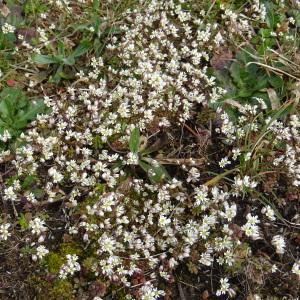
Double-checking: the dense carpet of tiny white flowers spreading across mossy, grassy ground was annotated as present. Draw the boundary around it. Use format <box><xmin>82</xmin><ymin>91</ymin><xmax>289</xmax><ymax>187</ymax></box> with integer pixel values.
<box><xmin>0</xmin><ymin>0</ymin><xmax>300</xmax><ymax>300</ymax></box>
